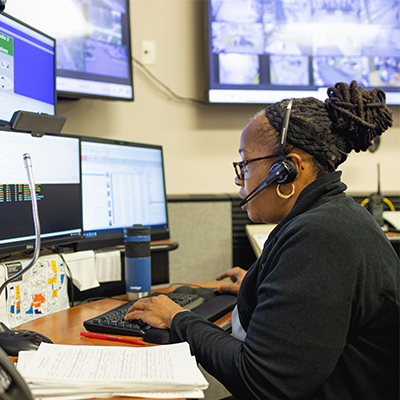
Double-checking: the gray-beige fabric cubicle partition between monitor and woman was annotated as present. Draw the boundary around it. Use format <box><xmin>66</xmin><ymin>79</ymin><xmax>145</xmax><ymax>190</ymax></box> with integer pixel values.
<box><xmin>168</xmin><ymin>194</ymin><xmax>233</xmax><ymax>283</ymax></box>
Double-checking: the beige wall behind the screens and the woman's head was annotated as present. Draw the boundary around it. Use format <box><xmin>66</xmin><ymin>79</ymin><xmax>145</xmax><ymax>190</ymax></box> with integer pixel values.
<box><xmin>58</xmin><ymin>0</ymin><xmax>400</xmax><ymax>194</ymax></box>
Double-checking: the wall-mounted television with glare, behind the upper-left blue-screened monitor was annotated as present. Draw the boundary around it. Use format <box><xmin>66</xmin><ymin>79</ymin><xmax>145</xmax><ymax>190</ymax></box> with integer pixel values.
<box><xmin>6</xmin><ymin>0</ymin><xmax>133</xmax><ymax>100</ymax></box>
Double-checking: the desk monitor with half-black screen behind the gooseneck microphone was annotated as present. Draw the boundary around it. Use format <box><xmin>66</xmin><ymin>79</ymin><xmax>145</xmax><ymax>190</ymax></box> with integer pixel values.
<box><xmin>0</xmin><ymin>131</ymin><xmax>82</xmax><ymax>254</ymax></box>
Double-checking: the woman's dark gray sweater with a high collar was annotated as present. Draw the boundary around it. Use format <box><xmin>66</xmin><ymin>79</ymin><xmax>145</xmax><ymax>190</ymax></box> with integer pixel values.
<box><xmin>171</xmin><ymin>172</ymin><xmax>400</xmax><ymax>400</ymax></box>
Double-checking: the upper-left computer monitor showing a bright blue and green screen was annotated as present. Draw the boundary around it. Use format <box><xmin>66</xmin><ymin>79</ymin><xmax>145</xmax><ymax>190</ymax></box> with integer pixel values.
<box><xmin>0</xmin><ymin>12</ymin><xmax>56</xmax><ymax>126</ymax></box>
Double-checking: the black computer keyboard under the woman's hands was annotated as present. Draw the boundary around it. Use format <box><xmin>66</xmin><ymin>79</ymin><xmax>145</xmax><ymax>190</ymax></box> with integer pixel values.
<box><xmin>83</xmin><ymin>292</ymin><xmax>204</xmax><ymax>336</ymax></box>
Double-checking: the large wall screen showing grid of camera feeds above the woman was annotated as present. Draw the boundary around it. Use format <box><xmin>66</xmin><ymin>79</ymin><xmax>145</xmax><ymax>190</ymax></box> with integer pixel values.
<box><xmin>208</xmin><ymin>0</ymin><xmax>400</xmax><ymax>104</ymax></box>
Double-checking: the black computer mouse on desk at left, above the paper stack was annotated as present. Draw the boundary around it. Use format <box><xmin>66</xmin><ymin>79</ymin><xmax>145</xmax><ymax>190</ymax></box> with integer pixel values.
<box><xmin>0</xmin><ymin>322</ymin><xmax>53</xmax><ymax>356</ymax></box>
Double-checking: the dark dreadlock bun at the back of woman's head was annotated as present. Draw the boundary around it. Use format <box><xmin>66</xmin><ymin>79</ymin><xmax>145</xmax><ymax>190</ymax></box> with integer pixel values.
<box><xmin>325</xmin><ymin>81</ymin><xmax>393</xmax><ymax>153</ymax></box>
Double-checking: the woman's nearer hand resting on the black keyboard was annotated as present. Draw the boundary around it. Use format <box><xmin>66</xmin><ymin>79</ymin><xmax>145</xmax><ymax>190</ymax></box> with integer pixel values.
<box><xmin>125</xmin><ymin>295</ymin><xmax>184</xmax><ymax>329</ymax></box>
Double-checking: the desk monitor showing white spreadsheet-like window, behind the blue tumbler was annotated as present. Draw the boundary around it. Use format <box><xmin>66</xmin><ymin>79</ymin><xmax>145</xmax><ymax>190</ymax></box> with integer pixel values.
<box><xmin>77</xmin><ymin>137</ymin><xmax>169</xmax><ymax>249</ymax></box>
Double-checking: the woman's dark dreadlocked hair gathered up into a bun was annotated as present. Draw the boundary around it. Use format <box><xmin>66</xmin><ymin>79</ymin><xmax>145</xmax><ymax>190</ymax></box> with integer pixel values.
<box><xmin>257</xmin><ymin>81</ymin><xmax>393</xmax><ymax>176</ymax></box>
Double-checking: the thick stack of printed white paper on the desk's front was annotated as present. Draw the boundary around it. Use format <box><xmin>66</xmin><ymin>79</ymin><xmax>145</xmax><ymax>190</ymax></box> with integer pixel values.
<box><xmin>17</xmin><ymin>343</ymin><xmax>208</xmax><ymax>400</ymax></box>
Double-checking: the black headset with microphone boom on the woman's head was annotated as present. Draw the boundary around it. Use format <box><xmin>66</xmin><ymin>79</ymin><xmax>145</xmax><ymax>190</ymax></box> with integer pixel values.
<box><xmin>239</xmin><ymin>99</ymin><xmax>297</xmax><ymax>207</ymax></box>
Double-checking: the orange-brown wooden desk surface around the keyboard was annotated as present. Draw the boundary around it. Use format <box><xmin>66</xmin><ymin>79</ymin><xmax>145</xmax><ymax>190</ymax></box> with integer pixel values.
<box><xmin>15</xmin><ymin>281</ymin><xmax>231</xmax><ymax>400</ymax></box>
